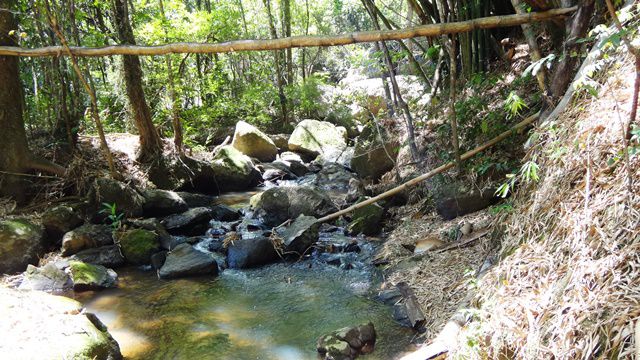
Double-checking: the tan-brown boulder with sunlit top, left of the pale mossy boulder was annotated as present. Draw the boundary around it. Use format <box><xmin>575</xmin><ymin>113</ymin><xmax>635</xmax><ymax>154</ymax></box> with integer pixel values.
<box><xmin>231</xmin><ymin>121</ymin><xmax>278</xmax><ymax>162</ymax></box>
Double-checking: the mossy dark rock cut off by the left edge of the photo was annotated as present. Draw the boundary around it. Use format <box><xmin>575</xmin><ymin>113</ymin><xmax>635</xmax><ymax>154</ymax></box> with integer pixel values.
<box><xmin>0</xmin><ymin>219</ymin><xmax>45</xmax><ymax>273</ymax></box>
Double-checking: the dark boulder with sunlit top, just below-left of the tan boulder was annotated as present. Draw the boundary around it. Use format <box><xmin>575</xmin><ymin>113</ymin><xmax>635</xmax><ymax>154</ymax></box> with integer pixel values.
<box><xmin>211</xmin><ymin>146</ymin><xmax>260</xmax><ymax>192</ymax></box>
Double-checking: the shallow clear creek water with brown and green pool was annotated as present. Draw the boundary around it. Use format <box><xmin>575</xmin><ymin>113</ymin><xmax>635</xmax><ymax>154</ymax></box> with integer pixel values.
<box><xmin>72</xmin><ymin>188</ymin><xmax>413</xmax><ymax>360</ymax></box>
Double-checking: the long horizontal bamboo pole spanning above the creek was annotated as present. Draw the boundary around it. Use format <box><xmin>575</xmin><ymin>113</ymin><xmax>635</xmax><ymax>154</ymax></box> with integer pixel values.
<box><xmin>0</xmin><ymin>6</ymin><xmax>578</xmax><ymax>57</ymax></box>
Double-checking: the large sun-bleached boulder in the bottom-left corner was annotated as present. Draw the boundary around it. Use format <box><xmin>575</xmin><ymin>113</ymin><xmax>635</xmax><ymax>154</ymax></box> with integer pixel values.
<box><xmin>0</xmin><ymin>287</ymin><xmax>122</xmax><ymax>360</ymax></box>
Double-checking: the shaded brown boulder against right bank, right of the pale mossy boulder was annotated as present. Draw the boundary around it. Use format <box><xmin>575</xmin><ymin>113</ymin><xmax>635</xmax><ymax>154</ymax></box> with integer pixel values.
<box><xmin>350</xmin><ymin>125</ymin><xmax>398</xmax><ymax>181</ymax></box>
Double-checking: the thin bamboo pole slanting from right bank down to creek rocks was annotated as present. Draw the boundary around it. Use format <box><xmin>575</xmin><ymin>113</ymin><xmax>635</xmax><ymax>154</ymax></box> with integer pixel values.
<box><xmin>318</xmin><ymin>113</ymin><xmax>540</xmax><ymax>223</ymax></box>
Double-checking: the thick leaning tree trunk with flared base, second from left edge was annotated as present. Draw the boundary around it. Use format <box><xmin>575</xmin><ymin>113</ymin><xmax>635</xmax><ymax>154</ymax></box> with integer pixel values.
<box><xmin>113</xmin><ymin>0</ymin><xmax>162</xmax><ymax>162</ymax></box>
